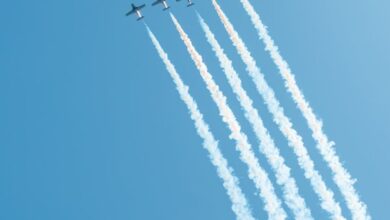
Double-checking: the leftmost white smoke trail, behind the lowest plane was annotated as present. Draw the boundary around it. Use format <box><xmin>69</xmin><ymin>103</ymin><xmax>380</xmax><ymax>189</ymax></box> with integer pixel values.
<box><xmin>146</xmin><ymin>26</ymin><xmax>255</xmax><ymax>220</ymax></box>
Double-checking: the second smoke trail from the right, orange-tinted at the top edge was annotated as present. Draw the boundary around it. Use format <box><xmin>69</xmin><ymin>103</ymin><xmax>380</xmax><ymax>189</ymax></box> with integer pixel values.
<box><xmin>213</xmin><ymin>0</ymin><xmax>345</xmax><ymax>219</ymax></box>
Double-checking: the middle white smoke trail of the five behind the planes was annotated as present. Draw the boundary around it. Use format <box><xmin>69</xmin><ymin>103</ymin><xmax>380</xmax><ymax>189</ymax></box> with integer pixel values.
<box><xmin>198</xmin><ymin>14</ymin><xmax>313</xmax><ymax>220</ymax></box>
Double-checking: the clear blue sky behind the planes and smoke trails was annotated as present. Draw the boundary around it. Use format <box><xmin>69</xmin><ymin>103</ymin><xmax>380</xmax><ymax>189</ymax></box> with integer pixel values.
<box><xmin>0</xmin><ymin>0</ymin><xmax>390</xmax><ymax>220</ymax></box>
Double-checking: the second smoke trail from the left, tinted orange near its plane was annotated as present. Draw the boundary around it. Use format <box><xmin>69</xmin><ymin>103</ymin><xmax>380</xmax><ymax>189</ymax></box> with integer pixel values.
<box><xmin>171</xmin><ymin>14</ymin><xmax>286</xmax><ymax>219</ymax></box>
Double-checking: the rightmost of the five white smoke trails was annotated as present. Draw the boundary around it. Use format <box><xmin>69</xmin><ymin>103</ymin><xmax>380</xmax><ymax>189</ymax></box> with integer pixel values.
<box><xmin>241</xmin><ymin>0</ymin><xmax>371</xmax><ymax>220</ymax></box>
